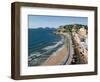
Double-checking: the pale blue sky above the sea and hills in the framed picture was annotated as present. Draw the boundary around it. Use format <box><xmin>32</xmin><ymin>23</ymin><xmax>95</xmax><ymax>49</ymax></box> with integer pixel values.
<box><xmin>28</xmin><ymin>15</ymin><xmax>88</xmax><ymax>28</ymax></box>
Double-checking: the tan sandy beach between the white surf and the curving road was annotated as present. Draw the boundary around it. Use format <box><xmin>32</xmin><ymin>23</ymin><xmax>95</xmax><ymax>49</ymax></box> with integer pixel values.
<box><xmin>42</xmin><ymin>45</ymin><xmax>68</xmax><ymax>66</ymax></box>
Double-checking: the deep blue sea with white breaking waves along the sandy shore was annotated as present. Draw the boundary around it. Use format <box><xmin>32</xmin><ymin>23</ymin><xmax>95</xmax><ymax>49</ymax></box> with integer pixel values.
<box><xmin>28</xmin><ymin>28</ymin><xmax>63</xmax><ymax>66</ymax></box>
